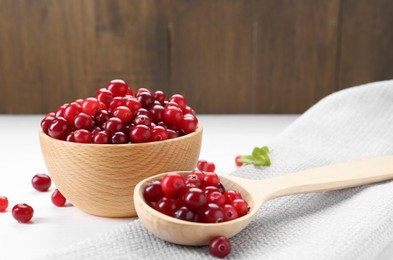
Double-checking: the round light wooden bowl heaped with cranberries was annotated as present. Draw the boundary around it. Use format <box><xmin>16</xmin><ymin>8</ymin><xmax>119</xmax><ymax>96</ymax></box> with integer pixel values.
<box><xmin>39</xmin><ymin>126</ymin><xmax>203</xmax><ymax>217</ymax></box>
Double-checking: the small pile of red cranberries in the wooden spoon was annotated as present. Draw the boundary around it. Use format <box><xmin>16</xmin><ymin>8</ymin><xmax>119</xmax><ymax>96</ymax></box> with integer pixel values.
<box><xmin>143</xmin><ymin>170</ymin><xmax>249</xmax><ymax>223</ymax></box>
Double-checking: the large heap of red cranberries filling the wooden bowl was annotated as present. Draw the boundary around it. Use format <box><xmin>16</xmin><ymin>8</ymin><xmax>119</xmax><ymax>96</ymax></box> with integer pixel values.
<box><xmin>41</xmin><ymin>79</ymin><xmax>198</xmax><ymax>144</ymax></box>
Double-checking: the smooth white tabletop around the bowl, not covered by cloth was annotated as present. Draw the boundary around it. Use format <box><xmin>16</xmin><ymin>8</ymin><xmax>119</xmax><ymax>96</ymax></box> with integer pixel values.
<box><xmin>0</xmin><ymin>115</ymin><xmax>393</xmax><ymax>259</ymax></box>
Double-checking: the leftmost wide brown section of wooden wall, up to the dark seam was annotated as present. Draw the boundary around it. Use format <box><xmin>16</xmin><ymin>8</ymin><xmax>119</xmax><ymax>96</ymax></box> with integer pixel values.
<box><xmin>0</xmin><ymin>0</ymin><xmax>168</xmax><ymax>113</ymax></box>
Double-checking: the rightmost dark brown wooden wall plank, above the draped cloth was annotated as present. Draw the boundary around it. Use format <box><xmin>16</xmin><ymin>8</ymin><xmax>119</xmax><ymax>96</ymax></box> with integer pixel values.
<box><xmin>337</xmin><ymin>0</ymin><xmax>393</xmax><ymax>89</ymax></box>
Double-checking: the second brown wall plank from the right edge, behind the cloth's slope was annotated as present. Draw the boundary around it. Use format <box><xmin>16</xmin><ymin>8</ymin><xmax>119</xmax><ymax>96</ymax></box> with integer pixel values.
<box><xmin>252</xmin><ymin>0</ymin><xmax>340</xmax><ymax>113</ymax></box>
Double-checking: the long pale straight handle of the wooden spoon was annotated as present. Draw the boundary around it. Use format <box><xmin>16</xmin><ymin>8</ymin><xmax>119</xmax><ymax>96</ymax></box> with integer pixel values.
<box><xmin>268</xmin><ymin>156</ymin><xmax>393</xmax><ymax>199</ymax></box>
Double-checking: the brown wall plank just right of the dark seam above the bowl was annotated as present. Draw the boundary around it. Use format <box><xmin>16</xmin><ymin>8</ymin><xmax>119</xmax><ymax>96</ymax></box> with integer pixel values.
<box><xmin>170</xmin><ymin>0</ymin><xmax>252</xmax><ymax>113</ymax></box>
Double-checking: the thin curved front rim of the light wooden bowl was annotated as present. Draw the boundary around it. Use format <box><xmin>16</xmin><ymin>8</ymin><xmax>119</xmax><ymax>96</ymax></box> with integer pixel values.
<box><xmin>38</xmin><ymin>124</ymin><xmax>203</xmax><ymax>147</ymax></box>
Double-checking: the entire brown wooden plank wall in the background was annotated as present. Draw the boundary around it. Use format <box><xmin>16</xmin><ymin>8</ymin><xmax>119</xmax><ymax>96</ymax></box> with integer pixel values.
<box><xmin>0</xmin><ymin>0</ymin><xmax>393</xmax><ymax>114</ymax></box>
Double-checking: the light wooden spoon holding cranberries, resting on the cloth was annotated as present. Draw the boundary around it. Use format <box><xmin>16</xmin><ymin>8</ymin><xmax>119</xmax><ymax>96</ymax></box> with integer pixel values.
<box><xmin>134</xmin><ymin>156</ymin><xmax>393</xmax><ymax>246</ymax></box>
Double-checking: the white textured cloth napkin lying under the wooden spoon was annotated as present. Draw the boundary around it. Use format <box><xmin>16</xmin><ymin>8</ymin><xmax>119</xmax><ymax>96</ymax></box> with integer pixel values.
<box><xmin>41</xmin><ymin>81</ymin><xmax>393</xmax><ymax>260</ymax></box>
